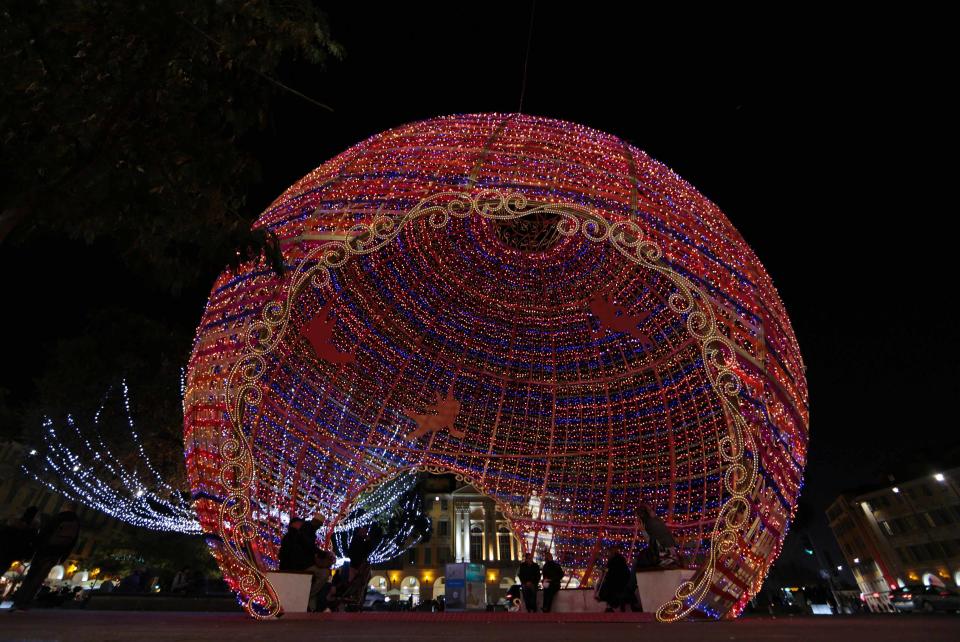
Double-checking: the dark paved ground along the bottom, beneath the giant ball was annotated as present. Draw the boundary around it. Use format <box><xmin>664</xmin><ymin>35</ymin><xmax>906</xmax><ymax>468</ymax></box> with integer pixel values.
<box><xmin>0</xmin><ymin>610</ymin><xmax>960</xmax><ymax>642</ymax></box>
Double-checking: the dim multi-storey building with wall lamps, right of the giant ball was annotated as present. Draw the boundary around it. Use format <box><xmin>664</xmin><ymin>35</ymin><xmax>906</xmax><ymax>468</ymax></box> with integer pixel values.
<box><xmin>827</xmin><ymin>468</ymin><xmax>960</xmax><ymax>611</ymax></box>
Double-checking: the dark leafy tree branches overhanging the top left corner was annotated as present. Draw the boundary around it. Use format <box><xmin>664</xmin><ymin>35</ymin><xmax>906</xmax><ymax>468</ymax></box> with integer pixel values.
<box><xmin>0</xmin><ymin>0</ymin><xmax>341</xmax><ymax>290</ymax></box>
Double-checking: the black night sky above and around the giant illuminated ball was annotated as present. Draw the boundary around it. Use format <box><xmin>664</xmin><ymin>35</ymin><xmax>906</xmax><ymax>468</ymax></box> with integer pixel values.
<box><xmin>0</xmin><ymin>2</ymin><xmax>960</xmax><ymax>556</ymax></box>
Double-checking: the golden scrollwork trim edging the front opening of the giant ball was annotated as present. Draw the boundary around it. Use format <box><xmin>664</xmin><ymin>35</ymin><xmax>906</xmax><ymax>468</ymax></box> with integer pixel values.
<box><xmin>219</xmin><ymin>190</ymin><xmax>758</xmax><ymax>622</ymax></box>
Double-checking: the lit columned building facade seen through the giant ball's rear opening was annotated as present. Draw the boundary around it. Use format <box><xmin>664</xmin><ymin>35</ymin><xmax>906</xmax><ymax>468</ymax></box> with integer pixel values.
<box><xmin>370</xmin><ymin>475</ymin><xmax>523</xmax><ymax>603</ymax></box>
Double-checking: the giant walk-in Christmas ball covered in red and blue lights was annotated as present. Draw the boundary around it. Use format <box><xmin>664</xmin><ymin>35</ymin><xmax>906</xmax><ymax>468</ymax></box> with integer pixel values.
<box><xmin>185</xmin><ymin>114</ymin><xmax>808</xmax><ymax>620</ymax></box>
